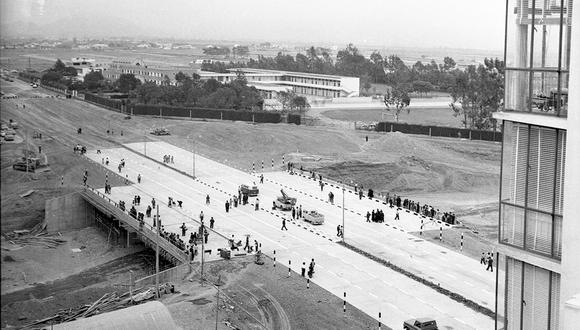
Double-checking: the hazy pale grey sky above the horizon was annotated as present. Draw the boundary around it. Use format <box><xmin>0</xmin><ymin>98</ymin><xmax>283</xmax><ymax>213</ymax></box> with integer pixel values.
<box><xmin>0</xmin><ymin>0</ymin><xmax>505</xmax><ymax>50</ymax></box>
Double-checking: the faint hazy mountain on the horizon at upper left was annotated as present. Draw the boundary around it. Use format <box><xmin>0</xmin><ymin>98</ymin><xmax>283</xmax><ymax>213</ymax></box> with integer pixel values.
<box><xmin>0</xmin><ymin>17</ymin><xmax>146</xmax><ymax>38</ymax></box>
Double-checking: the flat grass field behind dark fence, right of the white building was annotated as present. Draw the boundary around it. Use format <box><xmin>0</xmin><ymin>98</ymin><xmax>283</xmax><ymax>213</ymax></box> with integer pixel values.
<box><xmin>322</xmin><ymin>107</ymin><xmax>463</xmax><ymax>127</ymax></box>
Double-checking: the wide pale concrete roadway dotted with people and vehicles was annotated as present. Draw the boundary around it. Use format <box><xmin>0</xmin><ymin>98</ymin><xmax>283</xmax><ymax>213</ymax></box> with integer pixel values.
<box><xmin>87</xmin><ymin>142</ymin><xmax>495</xmax><ymax>329</ymax></box>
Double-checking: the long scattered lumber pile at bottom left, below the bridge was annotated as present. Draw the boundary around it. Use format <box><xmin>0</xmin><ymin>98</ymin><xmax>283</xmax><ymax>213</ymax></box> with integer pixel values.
<box><xmin>21</xmin><ymin>287</ymin><xmax>155</xmax><ymax>329</ymax></box>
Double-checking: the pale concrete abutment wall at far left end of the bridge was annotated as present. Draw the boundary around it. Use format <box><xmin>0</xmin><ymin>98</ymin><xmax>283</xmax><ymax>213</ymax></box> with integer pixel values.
<box><xmin>44</xmin><ymin>193</ymin><xmax>95</xmax><ymax>232</ymax></box>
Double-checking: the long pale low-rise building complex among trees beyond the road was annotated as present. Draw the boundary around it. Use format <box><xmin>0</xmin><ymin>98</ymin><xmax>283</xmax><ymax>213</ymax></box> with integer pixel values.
<box><xmin>103</xmin><ymin>60</ymin><xmax>360</xmax><ymax>99</ymax></box>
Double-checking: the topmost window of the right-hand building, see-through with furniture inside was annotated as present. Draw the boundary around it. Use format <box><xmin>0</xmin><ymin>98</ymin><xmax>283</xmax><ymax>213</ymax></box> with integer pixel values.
<box><xmin>504</xmin><ymin>0</ymin><xmax>572</xmax><ymax>116</ymax></box>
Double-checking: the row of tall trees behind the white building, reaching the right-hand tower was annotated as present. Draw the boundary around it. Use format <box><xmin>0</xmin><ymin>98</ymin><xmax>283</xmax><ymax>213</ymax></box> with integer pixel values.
<box><xmin>203</xmin><ymin>44</ymin><xmax>504</xmax><ymax>129</ymax></box>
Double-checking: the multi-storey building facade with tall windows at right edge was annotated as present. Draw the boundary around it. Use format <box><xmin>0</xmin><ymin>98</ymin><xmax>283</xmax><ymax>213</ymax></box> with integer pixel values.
<box><xmin>494</xmin><ymin>0</ymin><xmax>580</xmax><ymax>330</ymax></box>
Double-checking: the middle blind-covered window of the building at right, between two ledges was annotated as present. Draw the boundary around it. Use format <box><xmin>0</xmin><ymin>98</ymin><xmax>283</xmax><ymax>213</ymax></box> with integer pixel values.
<box><xmin>500</xmin><ymin>122</ymin><xmax>566</xmax><ymax>259</ymax></box>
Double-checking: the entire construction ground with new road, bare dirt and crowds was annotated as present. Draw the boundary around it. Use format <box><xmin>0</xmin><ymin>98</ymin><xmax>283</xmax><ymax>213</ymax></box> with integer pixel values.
<box><xmin>1</xmin><ymin>76</ymin><xmax>502</xmax><ymax>329</ymax></box>
